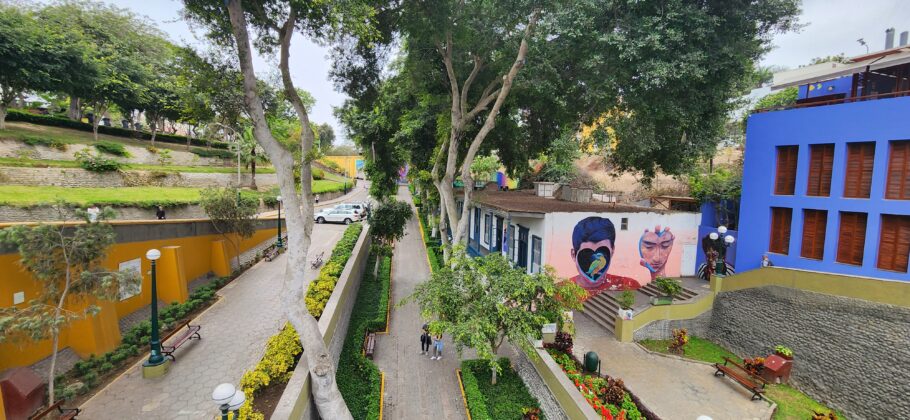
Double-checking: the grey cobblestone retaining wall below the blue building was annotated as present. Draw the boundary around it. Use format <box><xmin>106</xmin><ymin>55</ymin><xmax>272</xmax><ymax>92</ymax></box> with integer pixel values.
<box><xmin>707</xmin><ymin>286</ymin><xmax>910</xmax><ymax>419</ymax></box>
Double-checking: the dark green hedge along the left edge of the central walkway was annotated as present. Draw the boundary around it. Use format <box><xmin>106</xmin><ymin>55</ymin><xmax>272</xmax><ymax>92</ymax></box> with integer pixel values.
<box><xmin>335</xmin><ymin>249</ymin><xmax>392</xmax><ymax>420</ymax></box>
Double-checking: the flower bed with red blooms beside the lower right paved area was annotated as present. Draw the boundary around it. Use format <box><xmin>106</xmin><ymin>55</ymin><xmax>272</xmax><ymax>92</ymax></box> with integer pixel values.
<box><xmin>547</xmin><ymin>348</ymin><xmax>653</xmax><ymax>420</ymax></box>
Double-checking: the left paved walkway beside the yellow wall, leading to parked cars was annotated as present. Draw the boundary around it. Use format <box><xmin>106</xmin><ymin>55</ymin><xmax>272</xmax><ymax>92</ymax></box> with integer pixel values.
<box><xmin>80</xmin><ymin>225</ymin><xmax>345</xmax><ymax>420</ymax></box>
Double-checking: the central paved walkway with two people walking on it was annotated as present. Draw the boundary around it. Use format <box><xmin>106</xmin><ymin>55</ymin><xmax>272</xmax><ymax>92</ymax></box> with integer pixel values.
<box><xmin>375</xmin><ymin>187</ymin><xmax>467</xmax><ymax>419</ymax></box>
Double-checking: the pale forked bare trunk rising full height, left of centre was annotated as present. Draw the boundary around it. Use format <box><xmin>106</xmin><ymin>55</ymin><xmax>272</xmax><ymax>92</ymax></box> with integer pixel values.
<box><xmin>227</xmin><ymin>0</ymin><xmax>352</xmax><ymax>419</ymax></box>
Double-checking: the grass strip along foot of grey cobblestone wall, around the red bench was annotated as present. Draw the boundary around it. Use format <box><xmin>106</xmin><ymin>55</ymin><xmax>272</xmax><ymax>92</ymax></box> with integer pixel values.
<box><xmin>639</xmin><ymin>336</ymin><xmax>846</xmax><ymax>420</ymax></box>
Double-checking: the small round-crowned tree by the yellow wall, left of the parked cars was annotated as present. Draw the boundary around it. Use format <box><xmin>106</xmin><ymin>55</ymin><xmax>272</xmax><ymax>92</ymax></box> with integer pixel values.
<box><xmin>199</xmin><ymin>187</ymin><xmax>259</xmax><ymax>268</ymax></box>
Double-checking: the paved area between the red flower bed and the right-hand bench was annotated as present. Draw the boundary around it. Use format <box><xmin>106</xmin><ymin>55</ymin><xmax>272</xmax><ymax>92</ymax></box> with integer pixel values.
<box><xmin>574</xmin><ymin>315</ymin><xmax>772</xmax><ymax>420</ymax></box>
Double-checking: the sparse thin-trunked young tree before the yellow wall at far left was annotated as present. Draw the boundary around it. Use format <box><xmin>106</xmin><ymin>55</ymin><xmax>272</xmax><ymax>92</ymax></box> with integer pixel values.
<box><xmin>0</xmin><ymin>203</ymin><xmax>141</xmax><ymax>404</ymax></box>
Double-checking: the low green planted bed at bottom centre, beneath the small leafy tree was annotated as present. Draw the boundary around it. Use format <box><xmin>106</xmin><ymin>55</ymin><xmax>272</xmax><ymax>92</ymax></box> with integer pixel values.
<box><xmin>461</xmin><ymin>357</ymin><xmax>543</xmax><ymax>420</ymax></box>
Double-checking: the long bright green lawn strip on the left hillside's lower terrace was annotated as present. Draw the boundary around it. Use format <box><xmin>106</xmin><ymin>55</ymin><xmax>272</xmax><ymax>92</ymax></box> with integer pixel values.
<box><xmin>0</xmin><ymin>180</ymin><xmax>343</xmax><ymax>207</ymax></box>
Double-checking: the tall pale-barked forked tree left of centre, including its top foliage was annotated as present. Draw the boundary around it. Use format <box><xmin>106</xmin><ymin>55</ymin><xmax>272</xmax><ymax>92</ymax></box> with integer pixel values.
<box><xmin>185</xmin><ymin>0</ymin><xmax>372</xmax><ymax>419</ymax></box>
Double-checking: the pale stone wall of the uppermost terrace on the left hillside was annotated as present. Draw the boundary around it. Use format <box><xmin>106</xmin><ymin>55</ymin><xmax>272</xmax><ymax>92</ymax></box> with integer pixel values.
<box><xmin>0</xmin><ymin>139</ymin><xmax>225</xmax><ymax>166</ymax></box>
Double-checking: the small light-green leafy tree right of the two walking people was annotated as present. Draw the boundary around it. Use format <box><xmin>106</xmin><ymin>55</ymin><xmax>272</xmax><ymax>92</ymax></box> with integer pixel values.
<box><xmin>399</xmin><ymin>245</ymin><xmax>585</xmax><ymax>384</ymax></box>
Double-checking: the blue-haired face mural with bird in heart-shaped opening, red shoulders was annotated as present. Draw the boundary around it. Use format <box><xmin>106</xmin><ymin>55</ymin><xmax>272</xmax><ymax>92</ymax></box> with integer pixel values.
<box><xmin>571</xmin><ymin>217</ymin><xmax>640</xmax><ymax>293</ymax></box>
